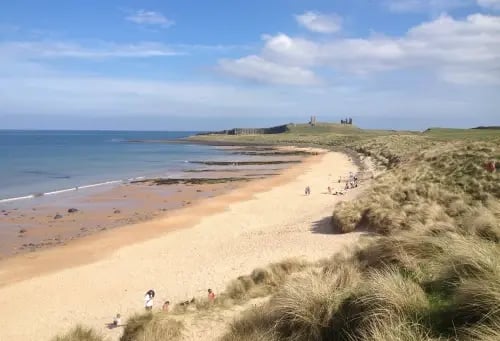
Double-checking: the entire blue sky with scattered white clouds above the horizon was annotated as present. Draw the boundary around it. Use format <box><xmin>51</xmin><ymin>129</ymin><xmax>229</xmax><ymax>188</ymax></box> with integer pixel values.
<box><xmin>0</xmin><ymin>0</ymin><xmax>500</xmax><ymax>130</ymax></box>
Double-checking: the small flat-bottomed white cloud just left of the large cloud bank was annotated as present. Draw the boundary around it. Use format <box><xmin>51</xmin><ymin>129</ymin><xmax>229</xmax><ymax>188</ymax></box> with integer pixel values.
<box><xmin>219</xmin><ymin>55</ymin><xmax>319</xmax><ymax>85</ymax></box>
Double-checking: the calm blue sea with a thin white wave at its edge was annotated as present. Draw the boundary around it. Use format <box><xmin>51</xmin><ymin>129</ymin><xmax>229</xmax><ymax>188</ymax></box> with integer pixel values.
<box><xmin>0</xmin><ymin>130</ymin><xmax>228</xmax><ymax>203</ymax></box>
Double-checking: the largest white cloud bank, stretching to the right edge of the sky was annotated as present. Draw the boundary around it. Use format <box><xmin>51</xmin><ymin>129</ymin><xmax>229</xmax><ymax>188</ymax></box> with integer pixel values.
<box><xmin>226</xmin><ymin>14</ymin><xmax>500</xmax><ymax>83</ymax></box>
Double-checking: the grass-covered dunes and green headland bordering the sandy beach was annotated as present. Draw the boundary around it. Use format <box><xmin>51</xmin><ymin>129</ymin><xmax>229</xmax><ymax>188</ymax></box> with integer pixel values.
<box><xmin>52</xmin><ymin>124</ymin><xmax>500</xmax><ymax>341</ymax></box>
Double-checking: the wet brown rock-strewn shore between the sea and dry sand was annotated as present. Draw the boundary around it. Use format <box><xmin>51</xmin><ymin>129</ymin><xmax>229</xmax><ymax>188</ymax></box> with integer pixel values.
<box><xmin>0</xmin><ymin>146</ymin><xmax>309</xmax><ymax>258</ymax></box>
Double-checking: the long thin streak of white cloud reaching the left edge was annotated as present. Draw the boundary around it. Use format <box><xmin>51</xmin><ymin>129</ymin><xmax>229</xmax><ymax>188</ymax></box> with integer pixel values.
<box><xmin>0</xmin><ymin>41</ymin><xmax>183</xmax><ymax>59</ymax></box>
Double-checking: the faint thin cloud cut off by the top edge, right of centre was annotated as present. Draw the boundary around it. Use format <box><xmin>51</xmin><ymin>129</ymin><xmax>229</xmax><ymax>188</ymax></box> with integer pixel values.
<box><xmin>384</xmin><ymin>0</ymin><xmax>470</xmax><ymax>14</ymax></box>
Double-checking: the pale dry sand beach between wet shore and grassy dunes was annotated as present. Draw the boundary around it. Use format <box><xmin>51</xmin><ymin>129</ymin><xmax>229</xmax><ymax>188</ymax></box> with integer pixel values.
<box><xmin>0</xmin><ymin>153</ymin><xmax>360</xmax><ymax>341</ymax></box>
